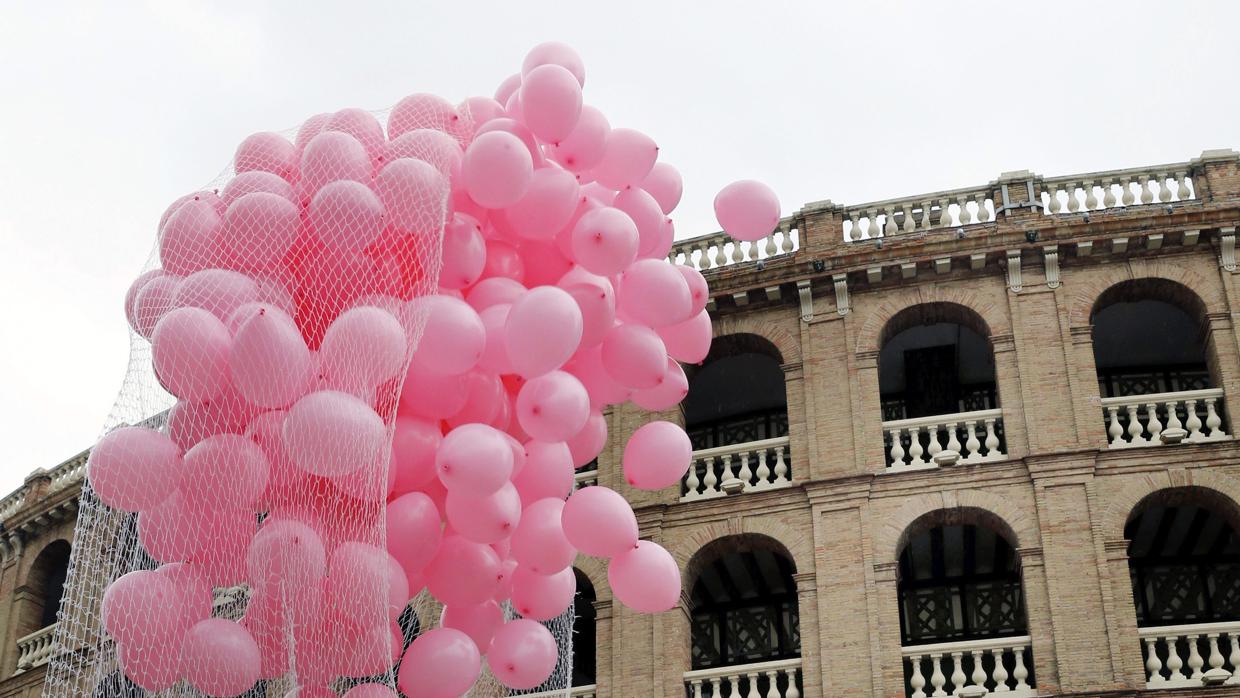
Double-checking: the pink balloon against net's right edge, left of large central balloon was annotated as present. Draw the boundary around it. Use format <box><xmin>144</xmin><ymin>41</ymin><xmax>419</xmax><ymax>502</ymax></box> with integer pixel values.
<box><xmin>414</xmin><ymin>295</ymin><xmax>486</xmax><ymax>374</ymax></box>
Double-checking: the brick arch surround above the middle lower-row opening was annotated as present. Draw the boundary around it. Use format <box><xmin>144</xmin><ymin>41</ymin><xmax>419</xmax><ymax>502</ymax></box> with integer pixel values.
<box><xmin>874</xmin><ymin>490</ymin><xmax>1040</xmax><ymax>562</ymax></box>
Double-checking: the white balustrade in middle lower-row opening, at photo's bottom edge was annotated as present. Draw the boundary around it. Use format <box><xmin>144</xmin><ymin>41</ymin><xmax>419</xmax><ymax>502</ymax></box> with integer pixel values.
<box><xmin>900</xmin><ymin>635</ymin><xmax>1038</xmax><ymax>698</ymax></box>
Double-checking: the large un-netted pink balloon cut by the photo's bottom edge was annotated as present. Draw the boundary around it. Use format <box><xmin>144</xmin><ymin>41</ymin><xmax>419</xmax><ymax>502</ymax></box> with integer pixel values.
<box><xmin>397</xmin><ymin>627</ymin><xmax>482</xmax><ymax>698</ymax></box>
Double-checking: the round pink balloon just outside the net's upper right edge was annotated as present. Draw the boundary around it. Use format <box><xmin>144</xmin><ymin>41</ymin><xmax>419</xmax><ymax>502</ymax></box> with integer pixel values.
<box><xmin>461</xmin><ymin>131</ymin><xmax>533</xmax><ymax>208</ymax></box>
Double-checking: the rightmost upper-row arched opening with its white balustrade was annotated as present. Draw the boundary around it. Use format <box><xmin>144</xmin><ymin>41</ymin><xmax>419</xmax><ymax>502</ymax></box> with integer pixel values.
<box><xmin>1090</xmin><ymin>279</ymin><xmax>1226</xmax><ymax>448</ymax></box>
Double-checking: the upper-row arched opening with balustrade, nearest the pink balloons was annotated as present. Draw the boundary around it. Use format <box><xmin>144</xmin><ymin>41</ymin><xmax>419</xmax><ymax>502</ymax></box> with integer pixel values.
<box><xmin>681</xmin><ymin>334</ymin><xmax>792</xmax><ymax>500</ymax></box>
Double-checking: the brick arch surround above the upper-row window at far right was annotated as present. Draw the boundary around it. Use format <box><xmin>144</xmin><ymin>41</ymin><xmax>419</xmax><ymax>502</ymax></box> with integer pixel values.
<box><xmin>1068</xmin><ymin>259</ymin><xmax>1228</xmax><ymax>327</ymax></box>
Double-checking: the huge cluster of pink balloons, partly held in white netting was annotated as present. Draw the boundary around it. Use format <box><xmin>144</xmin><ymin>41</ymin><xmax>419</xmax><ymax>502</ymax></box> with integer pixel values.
<box><xmin>88</xmin><ymin>43</ymin><xmax>719</xmax><ymax>698</ymax></box>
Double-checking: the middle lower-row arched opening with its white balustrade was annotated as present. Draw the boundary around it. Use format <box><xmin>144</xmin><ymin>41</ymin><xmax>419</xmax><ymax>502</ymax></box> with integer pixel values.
<box><xmin>897</xmin><ymin>511</ymin><xmax>1035</xmax><ymax>696</ymax></box>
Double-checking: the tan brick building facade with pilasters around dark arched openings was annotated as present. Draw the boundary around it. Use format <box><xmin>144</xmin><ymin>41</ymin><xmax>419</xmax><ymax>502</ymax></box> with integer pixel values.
<box><xmin>0</xmin><ymin>151</ymin><xmax>1240</xmax><ymax>698</ymax></box>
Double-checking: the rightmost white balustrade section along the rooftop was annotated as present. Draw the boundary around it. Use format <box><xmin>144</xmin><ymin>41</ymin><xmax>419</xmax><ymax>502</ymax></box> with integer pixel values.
<box><xmin>1038</xmin><ymin>162</ymin><xmax>1197</xmax><ymax>216</ymax></box>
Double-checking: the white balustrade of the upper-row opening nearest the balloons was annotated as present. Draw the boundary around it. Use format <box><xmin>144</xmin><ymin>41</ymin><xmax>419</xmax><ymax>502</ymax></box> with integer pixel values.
<box><xmin>681</xmin><ymin>436</ymin><xmax>792</xmax><ymax>502</ymax></box>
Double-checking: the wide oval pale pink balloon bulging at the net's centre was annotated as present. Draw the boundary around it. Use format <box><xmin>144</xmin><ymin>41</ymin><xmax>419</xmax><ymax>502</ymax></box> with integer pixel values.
<box><xmin>284</xmin><ymin>391</ymin><xmax>389</xmax><ymax>477</ymax></box>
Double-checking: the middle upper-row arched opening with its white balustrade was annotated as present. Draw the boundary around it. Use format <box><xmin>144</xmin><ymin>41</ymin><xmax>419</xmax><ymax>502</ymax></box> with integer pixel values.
<box><xmin>878</xmin><ymin>303</ymin><xmax>1007</xmax><ymax>469</ymax></box>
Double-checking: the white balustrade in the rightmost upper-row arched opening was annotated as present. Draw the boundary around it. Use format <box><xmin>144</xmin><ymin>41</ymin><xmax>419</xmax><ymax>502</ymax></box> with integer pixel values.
<box><xmin>1102</xmin><ymin>388</ymin><xmax>1231</xmax><ymax>449</ymax></box>
